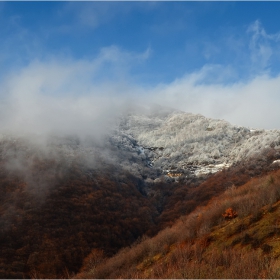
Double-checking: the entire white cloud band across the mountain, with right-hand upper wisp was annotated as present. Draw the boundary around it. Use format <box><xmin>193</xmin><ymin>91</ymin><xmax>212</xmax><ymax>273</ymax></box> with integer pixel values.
<box><xmin>0</xmin><ymin>18</ymin><xmax>280</xmax><ymax>140</ymax></box>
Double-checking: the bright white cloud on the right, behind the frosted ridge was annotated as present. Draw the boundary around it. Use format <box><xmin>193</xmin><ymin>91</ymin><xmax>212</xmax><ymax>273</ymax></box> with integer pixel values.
<box><xmin>151</xmin><ymin>66</ymin><xmax>280</xmax><ymax>129</ymax></box>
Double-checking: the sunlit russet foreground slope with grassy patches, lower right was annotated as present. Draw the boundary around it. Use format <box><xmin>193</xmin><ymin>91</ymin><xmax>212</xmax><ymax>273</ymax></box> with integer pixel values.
<box><xmin>76</xmin><ymin>167</ymin><xmax>280</xmax><ymax>279</ymax></box>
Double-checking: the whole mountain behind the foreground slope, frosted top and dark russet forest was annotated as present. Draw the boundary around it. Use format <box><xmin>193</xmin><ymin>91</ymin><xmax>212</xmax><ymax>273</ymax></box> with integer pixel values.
<box><xmin>0</xmin><ymin>105</ymin><xmax>280</xmax><ymax>278</ymax></box>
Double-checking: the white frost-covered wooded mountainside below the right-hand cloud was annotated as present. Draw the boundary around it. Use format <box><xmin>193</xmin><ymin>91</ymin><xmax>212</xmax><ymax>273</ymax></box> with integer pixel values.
<box><xmin>112</xmin><ymin>110</ymin><xmax>280</xmax><ymax>178</ymax></box>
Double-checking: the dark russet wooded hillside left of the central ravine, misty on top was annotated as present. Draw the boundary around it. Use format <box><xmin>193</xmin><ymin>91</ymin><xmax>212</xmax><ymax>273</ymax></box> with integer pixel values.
<box><xmin>0</xmin><ymin>135</ymin><xmax>160</xmax><ymax>279</ymax></box>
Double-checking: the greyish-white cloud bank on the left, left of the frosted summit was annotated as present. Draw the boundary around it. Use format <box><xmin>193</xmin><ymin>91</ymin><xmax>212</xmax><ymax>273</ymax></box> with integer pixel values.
<box><xmin>0</xmin><ymin>47</ymin><xmax>147</xmax><ymax>139</ymax></box>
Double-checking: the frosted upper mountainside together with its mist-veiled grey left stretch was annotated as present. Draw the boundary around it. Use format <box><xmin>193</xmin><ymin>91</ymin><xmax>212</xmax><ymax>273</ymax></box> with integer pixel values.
<box><xmin>0</xmin><ymin>108</ymin><xmax>280</xmax><ymax>185</ymax></box>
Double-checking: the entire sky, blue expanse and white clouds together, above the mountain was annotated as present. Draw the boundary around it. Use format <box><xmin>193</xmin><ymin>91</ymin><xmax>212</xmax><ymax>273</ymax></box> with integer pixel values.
<box><xmin>0</xmin><ymin>1</ymin><xmax>280</xmax><ymax>135</ymax></box>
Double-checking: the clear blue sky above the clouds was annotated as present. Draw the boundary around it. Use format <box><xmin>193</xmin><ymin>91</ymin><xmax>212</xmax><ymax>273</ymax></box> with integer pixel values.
<box><xmin>0</xmin><ymin>2</ymin><xmax>280</xmax><ymax>84</ymax></box>
